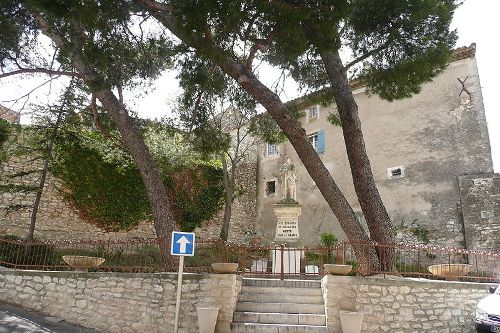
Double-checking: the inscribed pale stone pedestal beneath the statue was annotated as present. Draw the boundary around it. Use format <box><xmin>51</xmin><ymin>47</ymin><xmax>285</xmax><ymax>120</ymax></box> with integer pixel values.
<box><xmin>274</xmin><ymin>203</ymin><xmax>302</xmax><ymax>243</ymax></box>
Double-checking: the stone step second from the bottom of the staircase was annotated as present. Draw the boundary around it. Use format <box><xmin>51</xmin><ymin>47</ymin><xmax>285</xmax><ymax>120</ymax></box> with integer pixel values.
<box><xmin>233</xmin><ymin>311</ymin><xmax>326</xmax><ymax>326</ymax></box>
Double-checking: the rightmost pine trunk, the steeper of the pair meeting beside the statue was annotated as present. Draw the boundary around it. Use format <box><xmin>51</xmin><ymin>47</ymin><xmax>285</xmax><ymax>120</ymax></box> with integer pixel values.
<box><xmin>320</xmin><ymin>50</ymin><xmax>394</xmax><ymax>270</ymax></box>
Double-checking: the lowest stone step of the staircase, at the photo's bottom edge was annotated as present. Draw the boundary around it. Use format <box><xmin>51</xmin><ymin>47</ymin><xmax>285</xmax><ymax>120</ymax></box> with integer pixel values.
<box><xmin>231</xmin><ymin>323</ymin><xmax>333</xmax><ymax>333</ymax></box>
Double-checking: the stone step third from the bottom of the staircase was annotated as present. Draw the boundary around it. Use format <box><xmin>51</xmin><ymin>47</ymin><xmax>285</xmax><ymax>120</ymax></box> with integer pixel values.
<box><xmin>236</xmin><ymin>302</ymin><xmax>325</xmax><ymax>315</ymax></box>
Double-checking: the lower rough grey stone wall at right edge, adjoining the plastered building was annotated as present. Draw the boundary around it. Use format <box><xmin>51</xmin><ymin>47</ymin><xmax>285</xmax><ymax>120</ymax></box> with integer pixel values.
<box><xmin>459</xmin><ymin>173</ymin><xmax>500</xmax><ymax>252</ymax></box>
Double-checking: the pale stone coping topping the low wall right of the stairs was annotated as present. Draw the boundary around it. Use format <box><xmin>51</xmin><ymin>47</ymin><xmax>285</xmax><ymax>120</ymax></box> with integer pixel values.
<box><xmin>321</xmin><ymin>275</ymin><xmax>498</xmax><ymax>290</ymax></box>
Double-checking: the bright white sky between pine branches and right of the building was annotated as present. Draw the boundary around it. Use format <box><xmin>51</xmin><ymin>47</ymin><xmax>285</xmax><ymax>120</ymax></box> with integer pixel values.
<box><xmin>0</xmin><ymin>0</ymin><xmax>500</xmax><ymax>172</ymax></box>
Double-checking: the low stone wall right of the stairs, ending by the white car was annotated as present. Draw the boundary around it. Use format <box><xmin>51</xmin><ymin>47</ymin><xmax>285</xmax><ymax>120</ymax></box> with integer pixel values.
<box><xmin>322</xmin><ymin>275</ymin><xmax>489</xmax><ymax>333</ymax></box>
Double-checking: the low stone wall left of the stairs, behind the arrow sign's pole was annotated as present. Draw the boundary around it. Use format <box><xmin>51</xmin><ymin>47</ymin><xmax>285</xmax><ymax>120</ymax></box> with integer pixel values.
<box><xmin>0</xmin><ymin>270</ymin><xmax>241</xmax><ymax>333</ymax></box>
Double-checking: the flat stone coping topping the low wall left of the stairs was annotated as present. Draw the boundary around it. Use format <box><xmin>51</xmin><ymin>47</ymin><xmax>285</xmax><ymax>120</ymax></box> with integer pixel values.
<box><xmin>0</xmin><ymin>269</ymin><xmax>242</xmax><ymax>281</ymax></box>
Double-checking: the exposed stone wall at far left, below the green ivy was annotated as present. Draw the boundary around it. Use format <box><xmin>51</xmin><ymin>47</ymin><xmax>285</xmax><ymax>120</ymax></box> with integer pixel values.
<box><xmin>0</xmin><ymin>157</ymin><xmax>155</xmax><ymax>240</ymax></box>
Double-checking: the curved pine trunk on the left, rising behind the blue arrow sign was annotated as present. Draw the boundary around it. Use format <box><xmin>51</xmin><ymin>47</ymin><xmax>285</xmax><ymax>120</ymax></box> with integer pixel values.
<box><xmin>35</xmin><ymin>11</ymin><xmax>176</xmax><ymax>269</ymax></box>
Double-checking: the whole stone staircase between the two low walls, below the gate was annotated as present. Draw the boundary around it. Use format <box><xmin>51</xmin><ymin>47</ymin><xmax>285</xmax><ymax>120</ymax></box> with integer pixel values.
<box><xmin>231</xmin><ymin>279</ymin><xmax>332</xmax><ymax>333</ymax></box>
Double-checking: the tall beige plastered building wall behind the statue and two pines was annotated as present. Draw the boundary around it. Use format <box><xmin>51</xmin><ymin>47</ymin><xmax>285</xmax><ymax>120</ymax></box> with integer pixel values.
<box><xmin>257</xmin><ymin>46</ymin><xmax>500</xmax><ymax>248</ymax></box>
